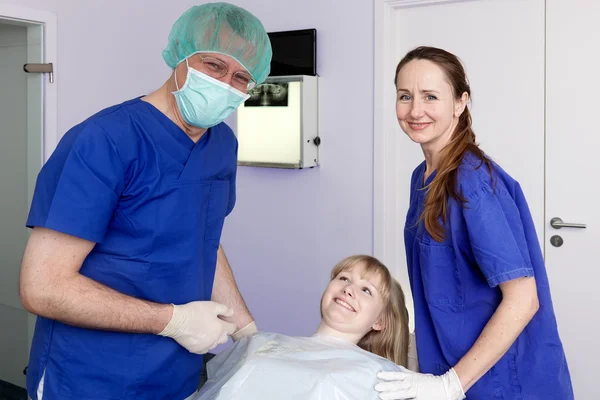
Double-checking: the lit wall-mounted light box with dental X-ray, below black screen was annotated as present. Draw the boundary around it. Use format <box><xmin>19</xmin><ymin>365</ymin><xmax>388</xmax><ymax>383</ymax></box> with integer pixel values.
<box><xmin>236</xmin><ymin>75</ymin><xmax>321</xmax><ymax>168</ymax></box>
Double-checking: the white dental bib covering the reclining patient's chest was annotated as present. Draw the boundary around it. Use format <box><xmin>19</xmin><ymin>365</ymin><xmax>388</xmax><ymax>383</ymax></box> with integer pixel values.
<box><xmin>194</xmin><ymin>333</ymin><xmax>404</xmax><ymax>400</ymax></box>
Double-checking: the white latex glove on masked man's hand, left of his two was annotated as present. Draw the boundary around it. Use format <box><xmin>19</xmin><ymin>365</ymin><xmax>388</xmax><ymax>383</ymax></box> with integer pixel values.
<box><xmin>159</xmin><ymin>301</ymin><xmax>235</xmax><ymax>354</ymax></box>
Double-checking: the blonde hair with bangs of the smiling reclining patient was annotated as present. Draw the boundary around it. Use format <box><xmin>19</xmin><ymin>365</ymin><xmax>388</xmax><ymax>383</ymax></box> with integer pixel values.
<box><xmin>331</xmin><ymin>255</ymin><xmax>409</xmax><ymax>367</ymax></box>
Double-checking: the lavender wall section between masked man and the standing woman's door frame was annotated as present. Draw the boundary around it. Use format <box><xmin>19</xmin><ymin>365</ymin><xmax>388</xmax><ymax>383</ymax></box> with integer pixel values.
<box><xmin>223</xmin><ymin>0</ymin><xmax>373</xmax><ymax>335</ymax></box>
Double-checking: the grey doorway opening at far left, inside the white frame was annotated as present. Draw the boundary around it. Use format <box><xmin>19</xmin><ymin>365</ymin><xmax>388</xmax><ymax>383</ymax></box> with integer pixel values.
<box><xmin>0</xmin><ymin>16</ymin><xmax>42</xmax><ymax>398</ymax></box>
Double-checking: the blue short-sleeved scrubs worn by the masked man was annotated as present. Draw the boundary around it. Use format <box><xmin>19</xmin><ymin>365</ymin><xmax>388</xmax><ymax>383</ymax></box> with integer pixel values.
<box><xmin>27</xmin><ymin>99</ymin><xmax>237</xmax><ymax>400</ymax></box>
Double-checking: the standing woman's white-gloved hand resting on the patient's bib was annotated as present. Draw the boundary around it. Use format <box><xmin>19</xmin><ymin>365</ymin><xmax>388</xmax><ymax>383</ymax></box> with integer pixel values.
<box><xmin>375</xmin><ymin>368</ymin><xmax>465</xmax><ymax>400</ymax></box>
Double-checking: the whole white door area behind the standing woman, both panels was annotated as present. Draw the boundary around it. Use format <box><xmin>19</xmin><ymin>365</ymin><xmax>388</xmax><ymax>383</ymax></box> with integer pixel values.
<box><xmin>374</xmin><ymin>0</ymin><xmax>600</xmax><ymax>400</ymax></box>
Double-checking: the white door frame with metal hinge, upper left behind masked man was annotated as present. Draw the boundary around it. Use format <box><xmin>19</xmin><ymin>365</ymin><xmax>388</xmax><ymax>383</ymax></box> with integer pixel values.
<box><xmin>0</xmin><ymin>4</ymin><xmax>59</xmax><ymax>163</ymax></box>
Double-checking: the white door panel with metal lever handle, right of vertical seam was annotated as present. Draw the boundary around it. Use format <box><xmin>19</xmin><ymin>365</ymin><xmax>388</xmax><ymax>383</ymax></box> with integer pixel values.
<box><xmin>544</xmin><ymin>0</ymin><xmax>600</xmax><ymax>400</ymax></box>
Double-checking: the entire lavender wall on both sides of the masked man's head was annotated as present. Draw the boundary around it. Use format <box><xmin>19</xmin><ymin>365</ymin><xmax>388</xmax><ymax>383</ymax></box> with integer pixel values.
<box><xmin>5</xmin><ymin>0</ymin><xmax>373</xmax><ymax>335</ymax></box>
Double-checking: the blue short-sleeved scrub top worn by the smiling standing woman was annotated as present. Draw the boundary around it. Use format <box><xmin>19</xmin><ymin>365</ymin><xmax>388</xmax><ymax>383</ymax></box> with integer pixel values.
<box><xmin>404</xmin><ymin>154</ymin><xmax>573</xmax><ymax>400</ymax></box>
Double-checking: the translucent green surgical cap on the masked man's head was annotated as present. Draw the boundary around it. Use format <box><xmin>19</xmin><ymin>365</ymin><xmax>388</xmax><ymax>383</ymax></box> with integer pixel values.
<box><xmin>163</xmin><ymin>3</ymin><xmax>273</xmax><ymax>83</ymax></box>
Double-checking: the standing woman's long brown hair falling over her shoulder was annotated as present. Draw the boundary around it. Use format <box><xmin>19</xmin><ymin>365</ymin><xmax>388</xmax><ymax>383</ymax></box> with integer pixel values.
<box><xmin>394</xmin><ymin>46</ymin><xmax>492</xmax><ymax>242</ymax></box>
